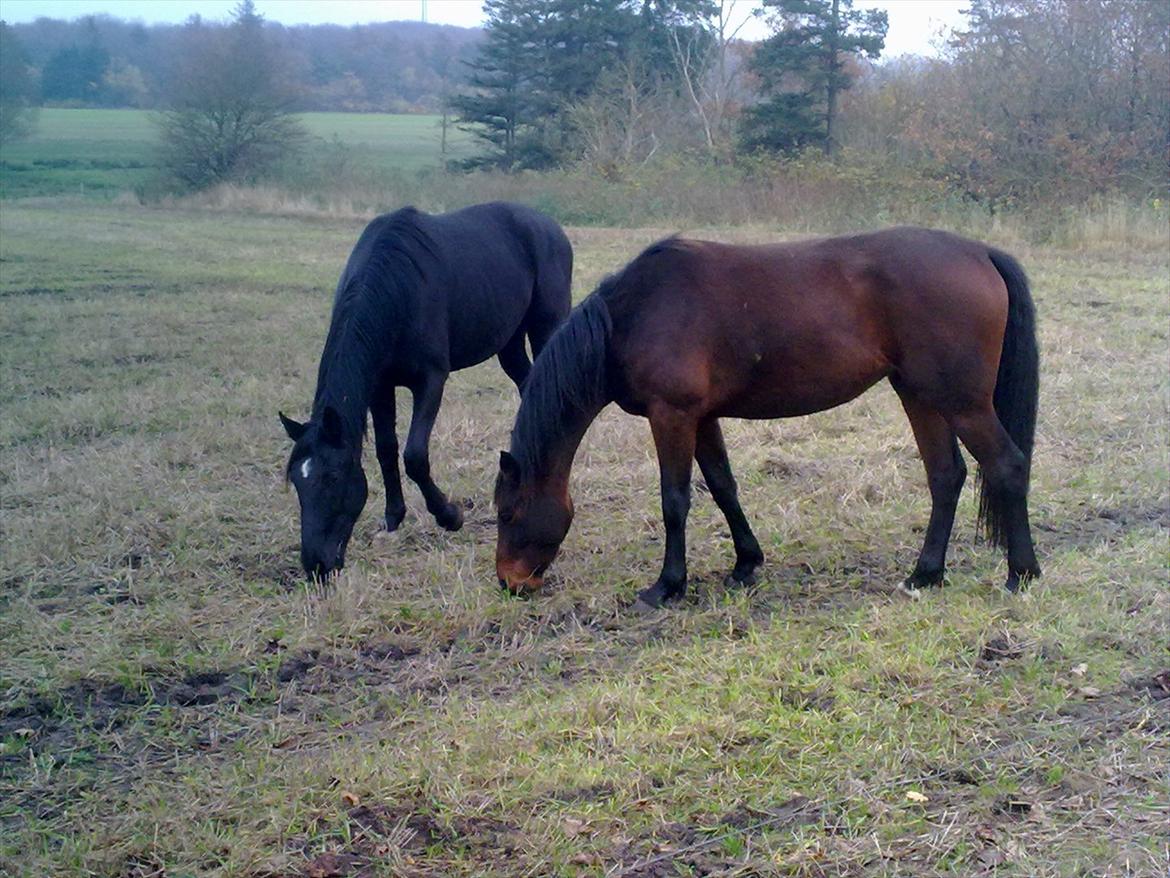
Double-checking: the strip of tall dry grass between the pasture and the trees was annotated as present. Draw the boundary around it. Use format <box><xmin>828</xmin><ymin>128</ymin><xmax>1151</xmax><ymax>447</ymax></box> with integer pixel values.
<box><xmin>163</xmin><ymin>169</ymin><xmax>1170</xmax><ymax>253</ymax></box>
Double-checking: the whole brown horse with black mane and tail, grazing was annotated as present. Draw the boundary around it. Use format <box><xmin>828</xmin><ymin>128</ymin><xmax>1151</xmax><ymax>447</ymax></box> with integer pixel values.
<box><xmin>496</xmin><ymin>228</ymin><xmax>1040</xmax><ymax>606</ymax></box>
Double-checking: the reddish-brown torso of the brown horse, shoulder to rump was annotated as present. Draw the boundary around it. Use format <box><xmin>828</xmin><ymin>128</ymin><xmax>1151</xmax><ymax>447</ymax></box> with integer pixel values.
<box><xmin>610</xmin><ymin>228</ymin><xmax>1006</xmax><ymax>418</ymax></box>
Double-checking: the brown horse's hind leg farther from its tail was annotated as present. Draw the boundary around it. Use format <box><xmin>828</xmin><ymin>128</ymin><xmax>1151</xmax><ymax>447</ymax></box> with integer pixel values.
<box><xmin>892</xmin><ymin>382</ymin><xmax>966</xmax><ymax>591</ymax></box>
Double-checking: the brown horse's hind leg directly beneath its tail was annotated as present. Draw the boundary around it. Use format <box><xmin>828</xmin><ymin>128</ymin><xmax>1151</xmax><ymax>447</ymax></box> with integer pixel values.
<box><xmin>950</xmin><ymin>402</ymin><xmax>1040</xmax><ymax>592</ymax></box>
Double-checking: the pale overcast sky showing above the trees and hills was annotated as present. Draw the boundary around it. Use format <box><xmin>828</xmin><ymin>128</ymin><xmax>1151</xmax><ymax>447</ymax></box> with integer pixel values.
<box><xmin>0</xmin><ymin>0</ymin><xmax>970</xmax><ymax>56</ymax></box>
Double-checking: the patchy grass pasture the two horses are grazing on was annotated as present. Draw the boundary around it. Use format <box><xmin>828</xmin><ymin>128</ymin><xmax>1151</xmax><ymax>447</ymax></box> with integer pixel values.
<box><xmin>0</xmin><ymin>199</ymin><xmax>1170</xmax><ymax>878</ymax></box>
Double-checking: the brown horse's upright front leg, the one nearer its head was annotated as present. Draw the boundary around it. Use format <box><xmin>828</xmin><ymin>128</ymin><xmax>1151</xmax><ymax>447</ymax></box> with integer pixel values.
<box><xmin>638</xmin><ymin>410</ymin><xmax>696</xmax><ymax>608</ymax></box>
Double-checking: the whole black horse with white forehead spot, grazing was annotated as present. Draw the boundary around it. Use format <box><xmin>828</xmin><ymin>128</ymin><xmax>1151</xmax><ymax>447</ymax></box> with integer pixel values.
<box><xmin>281</xmin><ymin>203</ymin><xmax>573</xmax><ymax>577</ymax></box>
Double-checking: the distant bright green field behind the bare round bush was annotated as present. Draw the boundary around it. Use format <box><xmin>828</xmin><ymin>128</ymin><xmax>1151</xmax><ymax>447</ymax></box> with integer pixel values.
<box><xmin>0</xmin><ymin>109</ymin><xmax>470</xmax><ymax>199</ymax></box>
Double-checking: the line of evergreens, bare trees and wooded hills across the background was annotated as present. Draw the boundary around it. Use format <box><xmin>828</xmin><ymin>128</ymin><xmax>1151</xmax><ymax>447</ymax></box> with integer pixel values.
<box><xmin>0</xmin><ymin>0</ymin><xmax>1170</xmax><ymax>205</ymax></box>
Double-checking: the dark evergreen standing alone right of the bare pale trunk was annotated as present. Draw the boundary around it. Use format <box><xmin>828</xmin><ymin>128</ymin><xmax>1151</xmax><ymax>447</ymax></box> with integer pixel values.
<box><xmin>742</xmin><ymin>0</ymin><xmax>888</xmax><ymax>153</ymax></box>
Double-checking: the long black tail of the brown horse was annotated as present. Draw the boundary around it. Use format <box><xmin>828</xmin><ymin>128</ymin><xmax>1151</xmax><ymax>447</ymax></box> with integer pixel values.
<box><xmin>979</xmin><ymin>249</ymin><xmax>1040</xmax><ymax>548</ymax></box>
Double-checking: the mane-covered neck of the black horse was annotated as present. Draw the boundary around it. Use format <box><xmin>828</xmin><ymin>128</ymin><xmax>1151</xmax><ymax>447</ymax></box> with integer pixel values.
<box><xmin>312</xmin><ymin>207</ymin><xmax>438</xmax><ymax>432</ymax></box>
